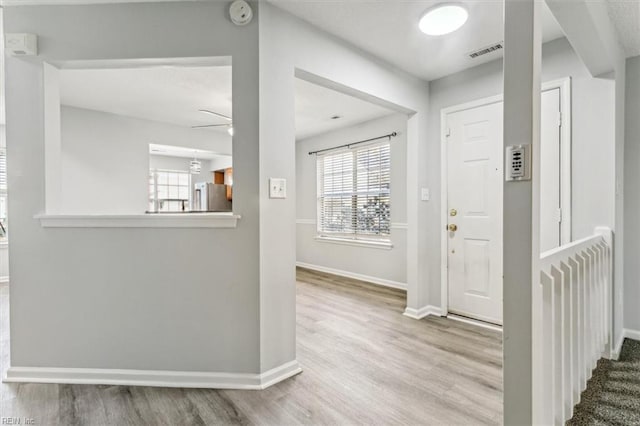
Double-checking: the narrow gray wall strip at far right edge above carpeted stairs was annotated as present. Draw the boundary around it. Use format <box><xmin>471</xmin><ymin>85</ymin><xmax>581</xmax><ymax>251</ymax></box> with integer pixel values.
<box><xmin>624</xmin><ymin>56</ymin><xmax>640</xmax><ymax>332</ymax></box>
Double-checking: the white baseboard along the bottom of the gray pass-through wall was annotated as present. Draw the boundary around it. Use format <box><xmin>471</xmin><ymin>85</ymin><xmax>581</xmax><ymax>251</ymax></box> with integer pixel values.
<box><xmin>3</xmin><ymin>360</ymin><xmax>302</xmax><ymax>390</ymax></box>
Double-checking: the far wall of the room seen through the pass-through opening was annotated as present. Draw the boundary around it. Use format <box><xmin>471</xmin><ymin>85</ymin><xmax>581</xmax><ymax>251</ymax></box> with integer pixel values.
<box><xmin>60</xmin><ymin>106</ymin><xmax>231</xmax><ymax>214</ymax></box>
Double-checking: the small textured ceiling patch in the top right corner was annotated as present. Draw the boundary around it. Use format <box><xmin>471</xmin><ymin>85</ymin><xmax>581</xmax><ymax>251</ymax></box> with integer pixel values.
<box><xmin>607</xmin><ymin>0</ymin><xmax>640</xmax><ymax>57</ymax></box>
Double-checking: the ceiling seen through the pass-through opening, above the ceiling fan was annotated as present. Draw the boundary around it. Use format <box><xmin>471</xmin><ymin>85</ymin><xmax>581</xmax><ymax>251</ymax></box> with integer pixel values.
<box><xmin>60</xmin><ymin>66</ymin><xmax>231</xmax><ymax>132</ymax></box>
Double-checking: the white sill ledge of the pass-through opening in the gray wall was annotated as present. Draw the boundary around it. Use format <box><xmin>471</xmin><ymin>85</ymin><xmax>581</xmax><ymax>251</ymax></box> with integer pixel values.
<box><xmin>34</xmin><ymin>213</ymin><xmax>240</xmax><ymax>228</ymax></box>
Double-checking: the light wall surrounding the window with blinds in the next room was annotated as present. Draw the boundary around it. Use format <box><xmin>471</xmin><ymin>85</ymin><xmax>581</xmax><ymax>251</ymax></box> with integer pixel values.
<box><xmin>296</xmin><ymin>114</ymin><xmax>407</xmax><ymax>287</ymax></box>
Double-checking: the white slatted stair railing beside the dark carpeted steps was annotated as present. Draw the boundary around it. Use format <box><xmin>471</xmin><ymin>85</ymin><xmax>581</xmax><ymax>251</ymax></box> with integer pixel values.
<box><xmin>532</xmin><ymin>228</ymin><xmax>613</xmax><ymax>425</ymax></box>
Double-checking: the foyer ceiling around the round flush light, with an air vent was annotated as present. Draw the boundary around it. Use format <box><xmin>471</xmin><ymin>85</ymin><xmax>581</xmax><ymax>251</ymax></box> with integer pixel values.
<box><xmin>268</xmin><ymin>0</ymin><xmax>564</xmax><ymax>80</ymax></box>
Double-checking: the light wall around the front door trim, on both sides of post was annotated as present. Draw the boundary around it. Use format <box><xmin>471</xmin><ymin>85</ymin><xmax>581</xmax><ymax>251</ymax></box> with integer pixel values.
<box><xmin>429</xmin><ymin>38</ymin><xmax>615</xmax><ymax>304</ymax></box>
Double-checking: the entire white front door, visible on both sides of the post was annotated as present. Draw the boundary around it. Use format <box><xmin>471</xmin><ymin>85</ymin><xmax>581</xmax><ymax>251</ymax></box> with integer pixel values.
<box><xmin>442</xmin><ymin>79</ymin><xmax>571</xmax><ymax>325</ymax></box>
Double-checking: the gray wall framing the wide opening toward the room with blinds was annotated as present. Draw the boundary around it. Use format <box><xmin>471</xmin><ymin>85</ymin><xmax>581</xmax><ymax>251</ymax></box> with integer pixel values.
<box><xmin>258</xmin><ymin>2</ymin><xmax>430</xmax><ymax>369</ymax></box>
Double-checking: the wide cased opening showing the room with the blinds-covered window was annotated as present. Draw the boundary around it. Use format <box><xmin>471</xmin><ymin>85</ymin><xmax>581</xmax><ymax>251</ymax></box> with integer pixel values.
<box><xmin>294</xmin><ymin>77</ymin><xmax>408</xmax><ymax>291</ymax></box>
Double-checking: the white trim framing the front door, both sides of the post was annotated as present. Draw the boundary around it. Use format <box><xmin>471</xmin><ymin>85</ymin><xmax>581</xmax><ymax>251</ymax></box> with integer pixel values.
<box><xmin>440</xmin><ymin>77</ymin><xmax>571</xmax><ymax>316</ymax></box>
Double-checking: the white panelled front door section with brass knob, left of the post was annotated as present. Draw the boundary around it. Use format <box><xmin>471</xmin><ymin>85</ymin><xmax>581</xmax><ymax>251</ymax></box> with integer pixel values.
<box><xmin>446</xmin><ymin>103</ymin><xmax>503</xmax><ymax>324</ymax></box>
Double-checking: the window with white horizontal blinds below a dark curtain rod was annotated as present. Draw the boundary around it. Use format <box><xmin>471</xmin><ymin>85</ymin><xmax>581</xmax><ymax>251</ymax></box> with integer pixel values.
<box><xmin>316</xmin><ymin>142</ymin><xmax>391</xmax><ymax>239</ymax></box>
